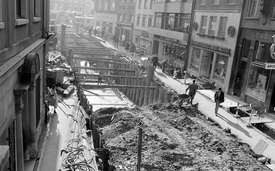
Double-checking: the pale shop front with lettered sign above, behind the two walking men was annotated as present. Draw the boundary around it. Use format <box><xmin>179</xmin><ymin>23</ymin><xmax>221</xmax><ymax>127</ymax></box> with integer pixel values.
<box><xmin>188</xmin><ymin>41</ymin><xmax>231</xmax><ymax>91</ymax></box>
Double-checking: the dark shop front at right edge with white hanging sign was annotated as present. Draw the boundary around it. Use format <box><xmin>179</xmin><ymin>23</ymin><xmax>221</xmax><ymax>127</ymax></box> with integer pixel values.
<box><xmin>232</xmin><ymin>29</ymin><xmax>275</xmax><ymax>113</ymax></box>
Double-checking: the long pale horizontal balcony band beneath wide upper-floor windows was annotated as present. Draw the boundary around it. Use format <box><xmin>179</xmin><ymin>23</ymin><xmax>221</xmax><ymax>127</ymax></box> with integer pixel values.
<box><xmin>149</xmin><ymin>27</ymin><xmax>189</xmax><ymax>43</ymax></box>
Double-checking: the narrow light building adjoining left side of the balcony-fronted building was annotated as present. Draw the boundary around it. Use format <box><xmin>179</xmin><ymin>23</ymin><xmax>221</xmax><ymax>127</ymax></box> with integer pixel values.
<box><xmin>132</xmin><ymin>0</ymin><xmax>154</xmax><ymax>54</ymax></box>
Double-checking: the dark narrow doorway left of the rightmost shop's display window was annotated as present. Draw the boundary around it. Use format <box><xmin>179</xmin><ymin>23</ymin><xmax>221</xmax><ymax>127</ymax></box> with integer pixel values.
<box><xmin>233</xmin><ymin>61</ymin><xmax>247</xmax><ymax>97</ymax></box>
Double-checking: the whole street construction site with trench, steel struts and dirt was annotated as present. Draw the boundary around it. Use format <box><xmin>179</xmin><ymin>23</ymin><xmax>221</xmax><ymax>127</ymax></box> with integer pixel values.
<box><xmin>34</xmin><ymin>25</ymin><xmax>275</xmax><ymax>171</ymax></box>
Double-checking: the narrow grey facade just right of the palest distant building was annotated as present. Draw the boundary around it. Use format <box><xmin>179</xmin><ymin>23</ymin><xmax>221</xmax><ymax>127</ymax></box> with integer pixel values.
<box><xmin>116</xmin><ymin>0</ymin><xmax>136</xmax><ymax>42</ymax></box>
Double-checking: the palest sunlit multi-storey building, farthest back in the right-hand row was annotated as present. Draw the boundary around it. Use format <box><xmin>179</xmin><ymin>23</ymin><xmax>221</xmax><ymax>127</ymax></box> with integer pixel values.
<box><xmin>94</xmin><ymin>0</ymin><xmax>118</xmax><ymax>36</ymax></box>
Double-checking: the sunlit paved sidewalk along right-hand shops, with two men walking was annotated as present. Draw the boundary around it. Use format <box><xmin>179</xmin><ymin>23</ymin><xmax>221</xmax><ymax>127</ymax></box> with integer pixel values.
<box><xmin>155</xmin><ymin>68</ymin><xmax>275</xmax><ymax>168</ymax></box>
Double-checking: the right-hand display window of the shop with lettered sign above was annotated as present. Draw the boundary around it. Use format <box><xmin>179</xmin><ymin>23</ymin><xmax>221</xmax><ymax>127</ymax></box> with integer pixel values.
<box><xmin>213</xmin><ymin>54</ymin><xmax>228</xmax><ymax>82</ymax></box>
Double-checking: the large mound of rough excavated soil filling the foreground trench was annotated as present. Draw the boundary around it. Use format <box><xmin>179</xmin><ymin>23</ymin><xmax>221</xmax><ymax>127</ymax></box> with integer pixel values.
<box><xmin>95</xmin><ymin>104</ymin><xmax>268</xmax><ymax>171</ymax></box>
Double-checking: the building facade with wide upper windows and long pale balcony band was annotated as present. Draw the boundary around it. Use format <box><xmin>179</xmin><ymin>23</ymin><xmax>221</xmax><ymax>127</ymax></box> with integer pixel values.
<box><xmin>148</xmin><ymin>0</ymin><xmax>193</xmax><ymax>68</ymax></box>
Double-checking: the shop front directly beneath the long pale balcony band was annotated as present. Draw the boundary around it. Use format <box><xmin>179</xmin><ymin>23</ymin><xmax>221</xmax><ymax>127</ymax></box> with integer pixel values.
<box><xmin>152</xmin><ymin>35</ymin><xmax>187</xmax><ymax>69</ymax></box>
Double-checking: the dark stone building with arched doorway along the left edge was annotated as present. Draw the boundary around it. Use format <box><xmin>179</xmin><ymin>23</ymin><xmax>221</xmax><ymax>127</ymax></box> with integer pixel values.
<box><xmin>0</xmin><ymin>0</ymin><xmax>51</xmax><ymax>171</ymax></box>
